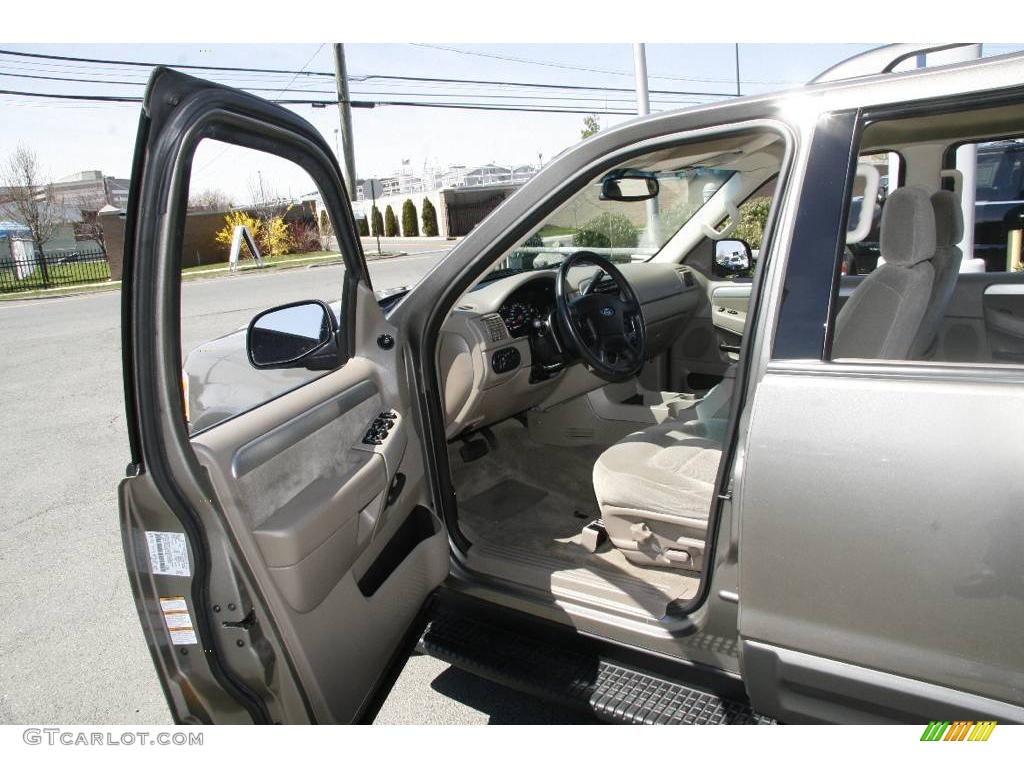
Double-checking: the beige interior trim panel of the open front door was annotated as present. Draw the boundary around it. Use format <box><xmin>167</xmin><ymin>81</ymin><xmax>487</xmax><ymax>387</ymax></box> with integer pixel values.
<box><xmin>193</xmin><ymin>331</ymin><xmax>447</xmax><ymax>722</ymax></box>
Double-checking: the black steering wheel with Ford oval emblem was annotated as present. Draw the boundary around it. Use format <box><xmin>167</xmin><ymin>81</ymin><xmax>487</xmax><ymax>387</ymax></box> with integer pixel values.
<box><xmin>555</xmin><ymin>251</ymin><xmax>647</xmax><ymax>381</ymax></box>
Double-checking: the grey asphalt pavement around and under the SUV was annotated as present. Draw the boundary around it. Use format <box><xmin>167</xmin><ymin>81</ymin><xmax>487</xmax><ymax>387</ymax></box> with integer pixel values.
<box><xmin>0</xmin><ymin>247</ymin><xmax>589</xmax><ymax>724</ymax></box>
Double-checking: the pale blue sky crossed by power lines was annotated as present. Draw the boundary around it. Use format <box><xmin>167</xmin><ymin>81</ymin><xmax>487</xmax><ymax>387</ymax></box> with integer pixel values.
<box><xmin>6</xmin><ymin>43</ymin><xmax>1024</xmax><ymax>202</ymax></box>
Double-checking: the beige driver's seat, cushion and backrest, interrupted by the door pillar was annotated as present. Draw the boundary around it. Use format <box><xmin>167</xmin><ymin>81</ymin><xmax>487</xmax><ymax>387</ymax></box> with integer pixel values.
<box><xmin>594</xmin><ymin>187</ymin><xmax>935</xmax><ymax>570</ymax></box>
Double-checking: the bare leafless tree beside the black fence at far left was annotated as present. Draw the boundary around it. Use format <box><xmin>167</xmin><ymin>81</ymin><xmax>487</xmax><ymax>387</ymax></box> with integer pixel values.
<box><xmin>0</xmin><ymin>144</ymin><xmax>63</xmax><ymax>285</ymax></box>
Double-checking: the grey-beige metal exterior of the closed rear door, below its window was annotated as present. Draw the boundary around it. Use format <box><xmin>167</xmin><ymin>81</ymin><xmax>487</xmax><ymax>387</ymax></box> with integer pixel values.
<box><xmin>737</xmin><ymin>370</ymin><xmax>1024</xmax><ymax>722</ymax></box>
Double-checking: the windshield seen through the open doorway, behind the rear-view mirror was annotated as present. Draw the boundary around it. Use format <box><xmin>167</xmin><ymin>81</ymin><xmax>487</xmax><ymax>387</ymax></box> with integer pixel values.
<box><xmin>481</xmin><ymin>155</ymin><xmax>733</xmax><ymax>283</ymax></box>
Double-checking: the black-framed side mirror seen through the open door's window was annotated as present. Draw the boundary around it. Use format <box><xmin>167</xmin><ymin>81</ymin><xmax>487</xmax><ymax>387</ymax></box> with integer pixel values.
<box><xmin>246</xmin><ymin>301</ymin><xmax>341</xmax><ymax>371</ymax></box>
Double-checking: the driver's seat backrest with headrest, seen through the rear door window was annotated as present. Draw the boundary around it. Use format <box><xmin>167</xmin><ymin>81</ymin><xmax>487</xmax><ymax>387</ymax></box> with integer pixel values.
<box><xmin>833</xmin><ymin>186</ymin><xmax>935</xmax><ymax>359</ymax></box>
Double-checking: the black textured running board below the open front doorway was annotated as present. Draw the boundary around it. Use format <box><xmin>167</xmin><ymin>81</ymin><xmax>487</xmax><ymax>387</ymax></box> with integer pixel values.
<box><xmin>418</xmin><ymin>610</ymin><xmax>773</xmax><ymax>725</ymax></box>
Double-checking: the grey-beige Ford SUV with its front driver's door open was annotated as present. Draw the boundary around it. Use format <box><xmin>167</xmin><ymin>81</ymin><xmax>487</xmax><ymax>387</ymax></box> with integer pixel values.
<box><xmin>119</xmin><ymin>45</ymin><xmax>1024</xmax><ymax>723</ymax></box>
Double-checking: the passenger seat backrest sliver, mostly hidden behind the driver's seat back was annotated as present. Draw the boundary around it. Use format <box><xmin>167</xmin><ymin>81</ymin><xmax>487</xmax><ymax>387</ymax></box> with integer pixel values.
<box><xmin>910</xmin><ymin>189</ymin><xmax>964</xmax><ymax>360</ymax></box>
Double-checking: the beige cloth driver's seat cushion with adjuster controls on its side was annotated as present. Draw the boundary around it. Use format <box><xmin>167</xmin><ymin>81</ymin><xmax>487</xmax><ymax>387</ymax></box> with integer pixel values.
<box><xmin>594</xmin><ymin>421</ymin><xmax>722</xmax><ymax>570</ymax></box>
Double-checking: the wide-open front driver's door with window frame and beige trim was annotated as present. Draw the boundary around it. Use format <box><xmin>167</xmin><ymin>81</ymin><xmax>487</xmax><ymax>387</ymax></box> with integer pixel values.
<box><xmin>119</xmin><ymin>69</ymin><xmax>449</xmax><ymax>723</ymax></box>
